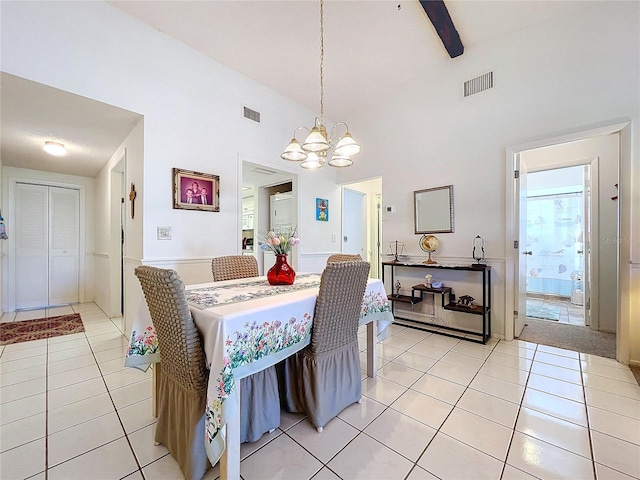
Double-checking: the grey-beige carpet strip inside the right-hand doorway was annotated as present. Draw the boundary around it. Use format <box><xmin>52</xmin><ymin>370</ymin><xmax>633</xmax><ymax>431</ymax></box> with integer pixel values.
<box><xmin>519</xmin><ymin>317</ymin><xmax>616</xmax><ymax>358</ymax></box>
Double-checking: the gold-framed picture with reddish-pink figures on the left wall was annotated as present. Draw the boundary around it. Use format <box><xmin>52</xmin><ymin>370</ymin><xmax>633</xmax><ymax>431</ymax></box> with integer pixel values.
<box><xmin>173</xmin><ymin>168</ymin><xmax>220</xmax><ymax>212</ymax></box>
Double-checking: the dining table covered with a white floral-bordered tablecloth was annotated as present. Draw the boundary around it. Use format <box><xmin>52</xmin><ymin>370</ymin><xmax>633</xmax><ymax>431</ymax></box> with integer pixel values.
<box><xmin>125</xmin><ymin>273</ymin><xmax>393</xmax><ymax>480</ymax></box>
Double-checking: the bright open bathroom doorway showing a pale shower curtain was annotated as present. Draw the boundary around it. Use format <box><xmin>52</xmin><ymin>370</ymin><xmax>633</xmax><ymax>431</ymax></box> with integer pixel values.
<box><xmin>523</xmin><ymin>164</ymin><xmax>591</xmax><ymax>326</ymax></box>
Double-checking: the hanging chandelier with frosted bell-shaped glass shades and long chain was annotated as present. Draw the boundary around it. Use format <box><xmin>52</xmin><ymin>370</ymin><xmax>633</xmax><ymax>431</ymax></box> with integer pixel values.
<box><xmin>280</xmin><ymin>0</ymin><xmax>360</xmax><ymax>169</ymax></box>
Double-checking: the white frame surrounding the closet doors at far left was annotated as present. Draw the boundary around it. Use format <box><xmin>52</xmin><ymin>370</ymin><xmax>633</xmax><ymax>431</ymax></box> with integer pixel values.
<box><xmin>2</xmin><ymin>176</ymin><xmax>86</xmax><ymax>312</ymax></box>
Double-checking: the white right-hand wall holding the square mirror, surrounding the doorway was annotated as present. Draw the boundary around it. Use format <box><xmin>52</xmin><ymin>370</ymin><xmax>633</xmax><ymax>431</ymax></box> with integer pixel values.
<box><xmin>338</xmin><ymin>1</ymin><xmax>640</xmax><ymax>362</ymax></box>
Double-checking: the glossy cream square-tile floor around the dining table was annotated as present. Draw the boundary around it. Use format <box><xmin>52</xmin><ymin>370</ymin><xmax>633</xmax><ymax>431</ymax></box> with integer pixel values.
<box><xmin>0</xmin><ymin>304</ymin><xmax>640</xmax><ymax>480</ymax></box>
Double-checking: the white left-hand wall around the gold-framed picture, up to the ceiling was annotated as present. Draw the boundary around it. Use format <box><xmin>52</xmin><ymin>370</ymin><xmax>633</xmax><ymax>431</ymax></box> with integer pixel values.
<box><xmin>0</xmin><ymin>2</ymin><xmax>339</xmax><ymax>330</ymax></box>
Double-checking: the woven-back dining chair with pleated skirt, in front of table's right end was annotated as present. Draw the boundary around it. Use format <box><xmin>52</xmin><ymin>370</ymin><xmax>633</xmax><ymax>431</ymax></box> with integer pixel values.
<box><xmin>279</xmin><ymin>261</ymin><xmax>370</xmax><ymax>433</ymax></box>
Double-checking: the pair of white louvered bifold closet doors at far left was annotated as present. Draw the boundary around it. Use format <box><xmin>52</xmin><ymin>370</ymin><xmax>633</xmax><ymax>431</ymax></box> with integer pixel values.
<box><xmin>15</xmin><ymin>184</ymin><xmax>80</xmax><ymax>309</ymax></box>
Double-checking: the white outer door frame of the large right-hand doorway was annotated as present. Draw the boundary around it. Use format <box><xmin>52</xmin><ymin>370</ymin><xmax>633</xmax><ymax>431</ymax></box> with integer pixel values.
<box><xmin>504</xmin><ymin>121</ymin><xmax>632</xmax><ymax>364</ymax></box>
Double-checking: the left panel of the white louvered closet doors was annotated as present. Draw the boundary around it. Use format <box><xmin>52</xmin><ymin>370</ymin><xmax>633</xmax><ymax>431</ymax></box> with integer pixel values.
<box><xmin>15</xmin><ymin>183</ymin><xmax>49</xmax><ymax>308</ymax></box>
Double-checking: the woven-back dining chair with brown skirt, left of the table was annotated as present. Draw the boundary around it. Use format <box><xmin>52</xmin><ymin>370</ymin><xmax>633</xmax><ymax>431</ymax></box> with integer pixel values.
<box><xmin>135</xmin><ymin>266</ymin><xmax>211</xmax><ymax>480</ymax></box>
